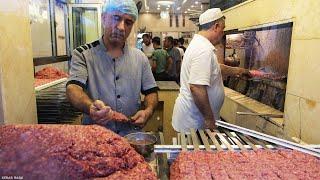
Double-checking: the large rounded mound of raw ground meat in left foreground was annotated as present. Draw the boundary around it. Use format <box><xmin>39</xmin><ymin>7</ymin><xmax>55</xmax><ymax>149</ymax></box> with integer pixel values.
<box><xmin>0</xmin><ymin>125</ymin><xmax>156</xmax><ymax>180</ymax></box>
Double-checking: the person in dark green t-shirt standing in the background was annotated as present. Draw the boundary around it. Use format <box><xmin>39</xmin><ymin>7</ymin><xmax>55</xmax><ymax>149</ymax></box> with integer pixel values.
<box><xmin>152</xmin><ymin>37</ymin><xmax>172</xmax><ymax>81</ymax></box>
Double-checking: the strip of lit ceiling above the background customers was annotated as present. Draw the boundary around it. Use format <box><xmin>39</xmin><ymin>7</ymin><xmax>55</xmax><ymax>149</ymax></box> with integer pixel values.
<box><xmin>134</xmin><ymin>0</ymin><xmax>210</xmax><ymax>15</ymax></box>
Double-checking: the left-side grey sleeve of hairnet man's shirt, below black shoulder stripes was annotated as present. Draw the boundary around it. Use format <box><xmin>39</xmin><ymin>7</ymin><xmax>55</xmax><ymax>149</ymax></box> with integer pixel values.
<box><xmin>67</xmin><ymin>50</ymin><xmax>88</xmax><ymax>89</ymax></box>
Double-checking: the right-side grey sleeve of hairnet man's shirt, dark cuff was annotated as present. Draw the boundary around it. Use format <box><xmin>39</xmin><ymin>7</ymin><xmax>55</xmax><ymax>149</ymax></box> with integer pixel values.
<box><xmin>141</xmin><ymin>52</ymin><xmax>158</xmax><ymax>95</ymax></box>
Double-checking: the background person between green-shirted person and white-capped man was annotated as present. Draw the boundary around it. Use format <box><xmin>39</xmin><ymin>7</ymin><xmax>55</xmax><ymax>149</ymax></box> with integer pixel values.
<box><xmin>163</xmin><ymin>36</ymin><xmax>181</xmax><ymax>83</ymax></box>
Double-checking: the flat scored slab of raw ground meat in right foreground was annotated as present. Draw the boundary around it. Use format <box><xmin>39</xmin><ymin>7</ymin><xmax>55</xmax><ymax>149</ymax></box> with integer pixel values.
<box><xmin>170</xmin><ymin>149</ymin><xmax>320</xmax><ymax>180</ymax></box>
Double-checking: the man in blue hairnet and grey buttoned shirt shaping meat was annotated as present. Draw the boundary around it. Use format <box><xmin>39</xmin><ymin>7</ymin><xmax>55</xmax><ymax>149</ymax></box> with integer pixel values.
<box><xmin>67</xmin><ymin>0</ymin><xmax>158</xmax><ymax>135</ymax></box>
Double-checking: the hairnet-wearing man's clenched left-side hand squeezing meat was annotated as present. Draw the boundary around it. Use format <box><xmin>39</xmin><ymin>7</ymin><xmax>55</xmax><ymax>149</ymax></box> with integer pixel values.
<box><xmin>90</xmin><ymin>100</ymin><xmax>113</xmax><ymax>125</ymax></box>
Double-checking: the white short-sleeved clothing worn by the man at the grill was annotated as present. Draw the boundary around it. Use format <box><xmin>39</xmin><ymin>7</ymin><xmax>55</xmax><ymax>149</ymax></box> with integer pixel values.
<box><xmin>172</xmin><ymin>34</ymin><xmax>224</xmax><ymax>132</ymax></box>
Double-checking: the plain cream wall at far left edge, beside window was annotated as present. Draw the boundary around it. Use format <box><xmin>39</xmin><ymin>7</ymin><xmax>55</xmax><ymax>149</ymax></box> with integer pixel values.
<box><xmin>0</xmin><ymin>0</ymin><xmax>37</xmax><ymax>124</ymax></box>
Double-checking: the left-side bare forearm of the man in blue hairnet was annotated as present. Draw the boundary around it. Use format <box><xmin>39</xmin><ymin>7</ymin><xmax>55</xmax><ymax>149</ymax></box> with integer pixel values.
<box><xmin>66</xmin><ymin>84</ymin><xmax>93</xmax><ymax>114</ymax></box>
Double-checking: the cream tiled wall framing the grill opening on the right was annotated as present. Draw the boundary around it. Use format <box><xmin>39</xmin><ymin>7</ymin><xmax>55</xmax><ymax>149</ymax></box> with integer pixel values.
<box><xmin>224</xmin><ymin>0</ymin><xmax>320</xmax><ymax>144</ymax></box>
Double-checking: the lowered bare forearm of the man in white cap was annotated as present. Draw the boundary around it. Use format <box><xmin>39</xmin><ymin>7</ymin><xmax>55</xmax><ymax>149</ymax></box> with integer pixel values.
<box><xmin>190</xmin><ymin>84</ymin><xmax>214</xmax><ymax>120</ymax></box>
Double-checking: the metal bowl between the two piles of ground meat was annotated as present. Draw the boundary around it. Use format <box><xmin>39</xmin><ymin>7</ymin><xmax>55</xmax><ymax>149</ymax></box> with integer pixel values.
<box><xmin>124</xmin><ymin>132</ymin><xmax>157</xmax><ymax>158</ymax></box>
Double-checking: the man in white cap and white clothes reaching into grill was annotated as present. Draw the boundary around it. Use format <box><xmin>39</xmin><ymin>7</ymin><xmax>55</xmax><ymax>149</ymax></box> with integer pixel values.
<box><xmin>172</xmin><ymin>8</ymin><xmax>248</xmax><ymax>133</ymax></box>
